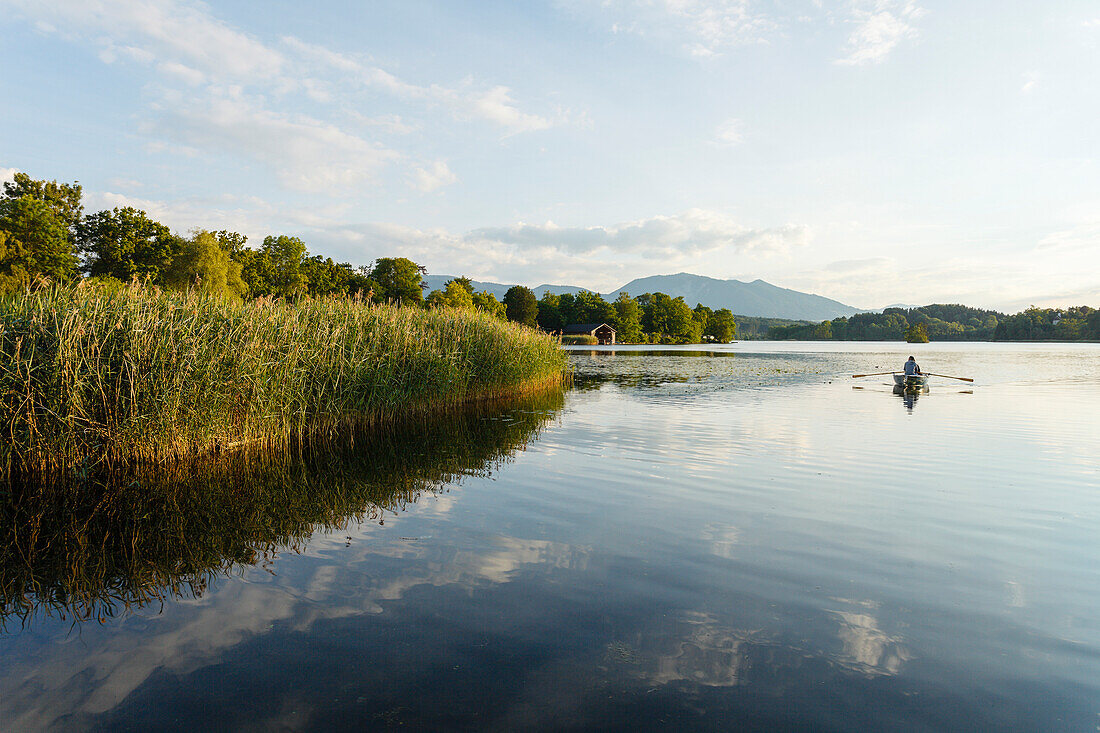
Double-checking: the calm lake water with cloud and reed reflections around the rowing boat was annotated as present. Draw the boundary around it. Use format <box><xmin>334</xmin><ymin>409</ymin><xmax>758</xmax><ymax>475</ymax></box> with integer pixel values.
<box><xmin>0</xmin><ymin>342</ymin><xmax>1100</xmax><ymax>731</ymax></box>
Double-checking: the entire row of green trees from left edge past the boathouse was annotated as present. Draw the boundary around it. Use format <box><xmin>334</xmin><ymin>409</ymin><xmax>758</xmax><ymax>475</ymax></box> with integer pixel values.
<box><xmin>0</xmin><ymin>173</ymin><xmax>737</xmax><ymax>343</ymax></box>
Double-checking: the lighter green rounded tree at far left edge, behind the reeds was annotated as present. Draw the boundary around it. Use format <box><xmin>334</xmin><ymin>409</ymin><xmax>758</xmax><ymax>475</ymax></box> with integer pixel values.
<box><xmin>0</xmin><ymin>193</ymin><xmax>77</xmax><ymax>288</ymax></box>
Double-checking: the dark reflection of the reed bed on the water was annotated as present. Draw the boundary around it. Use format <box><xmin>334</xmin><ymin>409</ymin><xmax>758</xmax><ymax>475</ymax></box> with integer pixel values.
<box><xmin>0</xmin><ymin>391</ymin><xmax>564</xmax><ymax>633</ymax></box>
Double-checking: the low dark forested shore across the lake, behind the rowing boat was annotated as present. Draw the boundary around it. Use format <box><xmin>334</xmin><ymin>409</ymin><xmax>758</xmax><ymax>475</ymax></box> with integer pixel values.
<box><xmin>768</xmin><ymin>304</ymin><xmax>1100</xmax><ymax>341</ymax></box>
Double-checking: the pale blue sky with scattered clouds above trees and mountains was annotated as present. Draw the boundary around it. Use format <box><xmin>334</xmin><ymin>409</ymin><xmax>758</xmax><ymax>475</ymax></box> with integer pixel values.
<box><xmin>0</xmin><ymin>0</ymin><xmax>1100</xmax><ymax>311</ymax></box>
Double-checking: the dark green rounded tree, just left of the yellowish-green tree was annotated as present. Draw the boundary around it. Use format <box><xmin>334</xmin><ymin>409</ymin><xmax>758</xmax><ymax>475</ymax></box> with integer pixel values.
<box><xmin>77</xmin><ymin>206</ymin><xmax>183</xmax><ymax>284</ymax></box>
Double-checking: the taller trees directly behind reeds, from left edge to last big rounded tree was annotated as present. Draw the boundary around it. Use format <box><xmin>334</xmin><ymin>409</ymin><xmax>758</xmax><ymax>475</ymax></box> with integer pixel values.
<box><xmin>0</xmin><ymin>173</ymin><xmax>437</xmax><ymax>304</ymax></box>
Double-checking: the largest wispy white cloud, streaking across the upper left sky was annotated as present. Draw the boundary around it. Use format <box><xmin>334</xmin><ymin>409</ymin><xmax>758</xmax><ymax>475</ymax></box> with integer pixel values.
<box><xmin>0</xmin><ymin>0</ymin><xmax>568</xmax><ymax>193</ymax></box>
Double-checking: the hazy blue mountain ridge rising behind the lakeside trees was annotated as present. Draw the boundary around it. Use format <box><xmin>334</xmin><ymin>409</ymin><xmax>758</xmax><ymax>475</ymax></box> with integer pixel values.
<box><xmin>424</xmin><ymin>272</ymin><xmax>867</xmax><ymax>320</ymax></box>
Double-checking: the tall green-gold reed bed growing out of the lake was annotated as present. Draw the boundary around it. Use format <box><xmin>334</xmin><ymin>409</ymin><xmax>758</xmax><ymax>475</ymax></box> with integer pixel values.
<box><xmin>0</xmin><ymin>285</ymin><xmax>567</xmax><ymax>471</ymax></box>
